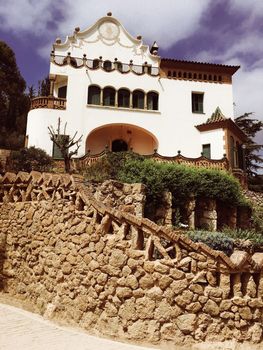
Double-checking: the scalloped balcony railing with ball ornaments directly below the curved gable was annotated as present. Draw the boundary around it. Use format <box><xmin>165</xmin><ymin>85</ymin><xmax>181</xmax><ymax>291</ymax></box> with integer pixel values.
<box><xmin>50</xmin><ymin>52</ymin><xmax>160</xmax><ymax>76</ymax></box>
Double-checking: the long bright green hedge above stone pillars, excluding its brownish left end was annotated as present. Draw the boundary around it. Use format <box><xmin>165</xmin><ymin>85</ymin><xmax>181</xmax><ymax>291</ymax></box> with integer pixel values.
<box><xmin>117</xmin><ymin>159</ymin><xmax>244</xmax><ymax>205</ymax></box>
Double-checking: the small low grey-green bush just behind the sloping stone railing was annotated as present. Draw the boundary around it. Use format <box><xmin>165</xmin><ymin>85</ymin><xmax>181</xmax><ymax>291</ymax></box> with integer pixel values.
<box><xmin>187</xmin><ymin>231</ymin><xmax>234</xmax><ymax>255</ymax></box>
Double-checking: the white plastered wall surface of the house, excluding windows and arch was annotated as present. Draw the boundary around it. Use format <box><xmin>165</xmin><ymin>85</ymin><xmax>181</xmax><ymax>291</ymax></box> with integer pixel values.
<box><xmin>27</xmin><ymin>18</ymin><xmax>233</xmax><ymax>158</ymax></box>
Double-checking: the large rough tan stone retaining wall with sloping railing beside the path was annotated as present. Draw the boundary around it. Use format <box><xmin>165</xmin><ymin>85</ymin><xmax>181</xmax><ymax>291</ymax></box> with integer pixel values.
<box><xmin>0</xmin><ymin>173</ymin><xmax>263</xmax><ymax>344</ymax></box>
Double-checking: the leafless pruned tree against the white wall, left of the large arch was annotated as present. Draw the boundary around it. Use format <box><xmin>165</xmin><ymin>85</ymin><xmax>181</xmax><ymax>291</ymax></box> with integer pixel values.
<box><xmin>48</xmin><ymin>118</ymin><xmax>82</xmax><ymax>173</ymax></box>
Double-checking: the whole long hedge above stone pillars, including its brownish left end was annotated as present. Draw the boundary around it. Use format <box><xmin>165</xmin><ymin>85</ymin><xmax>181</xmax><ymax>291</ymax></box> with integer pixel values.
<box><xmin>86</xmin><ymin>152</ymin><xmax>248</xmax><ymax>206</ymax></box>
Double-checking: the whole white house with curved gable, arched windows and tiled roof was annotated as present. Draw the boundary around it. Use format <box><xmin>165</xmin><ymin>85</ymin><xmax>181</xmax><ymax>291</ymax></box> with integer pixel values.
<box><xmin>27</xmin><ymin>13</ymin><xmax>248</xmax><ymax>167</ymax></box>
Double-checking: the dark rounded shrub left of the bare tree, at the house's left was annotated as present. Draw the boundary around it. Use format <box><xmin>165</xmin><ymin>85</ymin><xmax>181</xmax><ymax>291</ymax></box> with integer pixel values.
<box><xmin>9</xmin><ymin>147</ymin><xmax>53</xmax><ymax>172</ymax></box>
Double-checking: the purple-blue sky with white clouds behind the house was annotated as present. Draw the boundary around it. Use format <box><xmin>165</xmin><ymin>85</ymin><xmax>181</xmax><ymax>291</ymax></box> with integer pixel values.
<box><xmin>0</xmin><ymin>0</ymin><xmax>263</xmax><ymax>144</ymax></box>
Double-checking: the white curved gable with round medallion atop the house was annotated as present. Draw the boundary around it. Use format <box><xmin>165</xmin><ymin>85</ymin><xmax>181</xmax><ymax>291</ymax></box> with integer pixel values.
<box><xmin>53</xmin><ymin>16</ymin><xmax>160</xmax><ymax>67</ymax></box>
